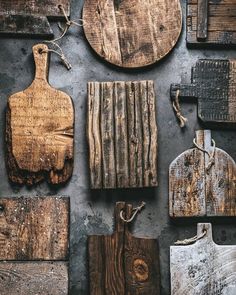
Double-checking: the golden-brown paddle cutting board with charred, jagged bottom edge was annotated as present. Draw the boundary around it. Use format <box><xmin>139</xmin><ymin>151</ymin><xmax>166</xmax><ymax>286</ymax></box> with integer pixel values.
<box><xmin>6</xmin><ymin>44</ymin><xmax>74</xmax><ymax>185</ymax></box>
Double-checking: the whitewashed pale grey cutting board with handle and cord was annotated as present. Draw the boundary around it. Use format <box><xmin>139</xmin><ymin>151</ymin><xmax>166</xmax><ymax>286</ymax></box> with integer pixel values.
<box><xmin>170</xmin><ymin>223</ymin><xmax>236</xmax><ymax>295</ymax></box>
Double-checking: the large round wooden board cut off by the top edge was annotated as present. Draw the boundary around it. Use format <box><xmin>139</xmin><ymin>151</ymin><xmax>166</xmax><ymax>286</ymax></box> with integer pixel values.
<box><xmin>83</xmin><ymin>0</ymin><xmax>182</xmax><ymax>68</ymax></box>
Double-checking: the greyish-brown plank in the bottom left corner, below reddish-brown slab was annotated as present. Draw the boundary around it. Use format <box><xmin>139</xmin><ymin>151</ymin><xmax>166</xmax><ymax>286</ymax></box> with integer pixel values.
<box><xmin>0</xmin><ymin>262</ymin><xmax>68</xmax><ymax>295</ymax></box>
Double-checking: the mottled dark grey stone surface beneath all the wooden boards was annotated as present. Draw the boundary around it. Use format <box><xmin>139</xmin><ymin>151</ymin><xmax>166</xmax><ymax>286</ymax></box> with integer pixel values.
<box><xmin>0</xmin><ymin>0</ymin><xmax>236</xmax><ymax>295</ymax></box>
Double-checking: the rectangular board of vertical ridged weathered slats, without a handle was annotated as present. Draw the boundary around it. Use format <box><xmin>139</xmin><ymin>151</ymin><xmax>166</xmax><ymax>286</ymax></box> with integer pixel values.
<box><xmin>87</xmin><ymin>81</ymin><xmax>157</xmax><ymax>189</ymax></box>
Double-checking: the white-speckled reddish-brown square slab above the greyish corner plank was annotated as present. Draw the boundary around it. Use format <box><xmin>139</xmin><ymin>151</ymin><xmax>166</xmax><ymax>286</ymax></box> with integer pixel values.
<box><xmin>0</xmin><ymin>197</ymin><xmax>70</xmax><ymax>260</ymax></box>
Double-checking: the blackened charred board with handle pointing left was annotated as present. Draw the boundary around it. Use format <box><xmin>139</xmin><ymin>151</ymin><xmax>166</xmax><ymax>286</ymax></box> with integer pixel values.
<box><xmin>171</xmin><ymin>59</ymin><xmax>236</xmax><ymax>128</ymax></box>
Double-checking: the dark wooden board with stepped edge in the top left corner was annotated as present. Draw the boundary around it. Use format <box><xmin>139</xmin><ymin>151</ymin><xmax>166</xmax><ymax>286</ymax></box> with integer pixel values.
<box><xmin>0</xmin><ymin>0</ymin><xmax>70</xmax><ymax>38</ymax></box>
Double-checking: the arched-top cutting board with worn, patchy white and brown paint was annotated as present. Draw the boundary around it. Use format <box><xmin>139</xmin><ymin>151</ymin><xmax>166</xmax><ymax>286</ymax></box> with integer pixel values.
<box><xmin>169</xmin><ymin>130</ymin><xmax>236</xmax><ymax>218</ymax></box>
